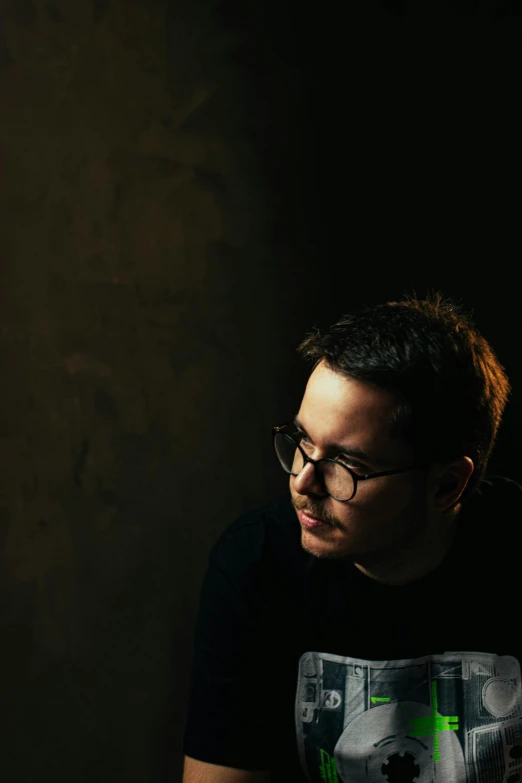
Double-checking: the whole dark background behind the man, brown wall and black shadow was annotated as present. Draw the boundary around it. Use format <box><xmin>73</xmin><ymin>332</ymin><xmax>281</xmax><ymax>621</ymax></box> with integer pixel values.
<box><xmin>0</xmin><ymin>0</ymin><xmax>522</xmax><ymax>783</ymax></box>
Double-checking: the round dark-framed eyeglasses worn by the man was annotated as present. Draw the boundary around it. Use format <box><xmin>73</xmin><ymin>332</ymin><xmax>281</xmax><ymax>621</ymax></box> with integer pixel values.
<box><xmin>272</xmin><ymin>424</ymin><xmax>425</xmax><ymax>503</ymax></box>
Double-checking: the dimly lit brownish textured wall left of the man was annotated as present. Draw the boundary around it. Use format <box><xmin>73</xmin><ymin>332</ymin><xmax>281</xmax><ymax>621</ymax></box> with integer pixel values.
<box><xmin>0</xmin><ymin>0</ymin><xmax>302</xmax><ymax>783</ymax></box>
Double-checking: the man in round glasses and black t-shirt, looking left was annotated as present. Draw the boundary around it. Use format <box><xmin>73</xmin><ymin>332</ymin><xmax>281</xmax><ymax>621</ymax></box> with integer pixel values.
<box><xmin>183</xmin><ymin>294</ymin><xmax>522</xmax><ymax>783</ymax></box>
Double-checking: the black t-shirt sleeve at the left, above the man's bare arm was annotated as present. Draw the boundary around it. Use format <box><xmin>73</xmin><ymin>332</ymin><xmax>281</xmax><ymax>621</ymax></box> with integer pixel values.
<box><xmin>183</xmin><ymin>525</ymin><xmax>277</xmax><ymax>770</ymax></box>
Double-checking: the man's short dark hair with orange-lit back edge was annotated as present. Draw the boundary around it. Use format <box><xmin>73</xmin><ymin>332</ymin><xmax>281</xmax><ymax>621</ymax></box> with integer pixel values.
<box><xmin>297</xmin><ymin>292</ymin><xmax>511</xmax><ymax>500</ymax></box>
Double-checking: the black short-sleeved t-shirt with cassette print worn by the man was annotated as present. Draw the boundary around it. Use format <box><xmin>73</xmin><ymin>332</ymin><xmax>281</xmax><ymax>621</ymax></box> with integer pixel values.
<box><xmin>183</xmin><ymin>478</ymin><xmax>522</xmax><ymax>783</ymax></box>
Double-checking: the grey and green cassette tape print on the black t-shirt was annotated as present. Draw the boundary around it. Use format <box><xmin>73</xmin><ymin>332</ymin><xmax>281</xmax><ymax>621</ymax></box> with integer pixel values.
<box><xmin>295</xmin><ymin>652</ymin><xmax>522</xmax><ymax>783</ymax></box>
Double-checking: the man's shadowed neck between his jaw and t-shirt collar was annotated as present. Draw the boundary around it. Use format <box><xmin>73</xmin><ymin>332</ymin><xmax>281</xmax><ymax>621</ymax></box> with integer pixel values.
<box><xmin>354</xmin><ymin>508</ymin><xmax>460</xmax><ymax>585</ymax></box>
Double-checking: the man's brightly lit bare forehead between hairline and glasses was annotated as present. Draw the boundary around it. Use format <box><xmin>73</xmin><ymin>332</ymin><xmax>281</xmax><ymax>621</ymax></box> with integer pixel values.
<box><xmin>299</xmin><ymin>363</ymin><xmax>399</xmax><ymax>457</ymax></box>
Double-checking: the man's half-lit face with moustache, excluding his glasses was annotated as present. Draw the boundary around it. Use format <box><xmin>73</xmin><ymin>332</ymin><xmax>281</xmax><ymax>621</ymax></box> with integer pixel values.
<box><xmin>290</xmin><ymin>362</ymin><xmax>428</xmax><ymax>562</ymax></box>
